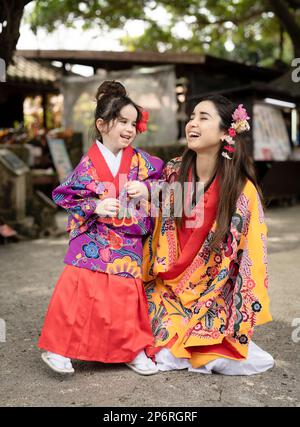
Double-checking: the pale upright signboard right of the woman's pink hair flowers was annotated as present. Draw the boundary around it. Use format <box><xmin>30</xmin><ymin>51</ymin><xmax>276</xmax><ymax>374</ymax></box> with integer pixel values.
<box><xmin>253</xmin><ymin>103</ymin><xmax>292</xmax><ymax>161</ymax></box>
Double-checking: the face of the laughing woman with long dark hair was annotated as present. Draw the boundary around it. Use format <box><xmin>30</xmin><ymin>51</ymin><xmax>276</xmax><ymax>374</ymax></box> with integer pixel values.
<box><xmin>185</xmin><ymin>101</ymin><xmax>225</xmax><ymax>153</ymax></box>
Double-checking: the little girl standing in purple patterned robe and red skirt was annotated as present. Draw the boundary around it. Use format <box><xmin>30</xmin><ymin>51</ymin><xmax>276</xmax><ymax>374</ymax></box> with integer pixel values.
<box><xmin>38</xmin><ymin>81</ymin><xmax>163</xmax><ymax>375</ymax></box>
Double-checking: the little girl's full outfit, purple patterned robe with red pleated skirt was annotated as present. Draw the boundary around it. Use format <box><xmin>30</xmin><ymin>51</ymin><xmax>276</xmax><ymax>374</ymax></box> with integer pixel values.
<box><xmin>38</xmin><ymin>141</ymin><xmax>163</xmax><ymax>363</ymax></box>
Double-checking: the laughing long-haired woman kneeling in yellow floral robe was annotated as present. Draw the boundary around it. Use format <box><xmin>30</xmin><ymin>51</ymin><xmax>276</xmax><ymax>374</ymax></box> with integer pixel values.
<box><xmin>144</xmin><ymin>95</ymin><xmax>274</xmax><ymax>375</ymax></box>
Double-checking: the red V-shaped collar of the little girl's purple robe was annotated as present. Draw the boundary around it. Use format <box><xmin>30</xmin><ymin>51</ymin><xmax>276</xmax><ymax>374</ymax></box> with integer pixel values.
<box><xmin>87</xmin><ymin>142</ymin><xmax>134</xmax><ymax>198</ymax></box>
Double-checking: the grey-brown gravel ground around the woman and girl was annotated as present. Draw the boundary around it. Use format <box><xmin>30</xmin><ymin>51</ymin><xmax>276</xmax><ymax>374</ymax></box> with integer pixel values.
<box><xmin>0</xmin><ymin>205</ymin><xmax>300</xmax><ymax>407</ymax></box>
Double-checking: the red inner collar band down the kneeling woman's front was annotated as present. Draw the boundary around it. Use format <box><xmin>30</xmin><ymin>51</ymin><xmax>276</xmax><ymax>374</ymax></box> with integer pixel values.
<box><xmin>158</xmin><ymin>172</ymin><xmax>219</xmax><ymax>280</ymax></box>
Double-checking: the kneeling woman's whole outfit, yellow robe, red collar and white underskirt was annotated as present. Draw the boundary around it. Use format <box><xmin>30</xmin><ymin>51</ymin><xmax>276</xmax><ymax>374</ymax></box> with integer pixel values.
<box><xmin>143</xmin><ymin>158</ymin><xmax>274</xmax><ymax>375</ymax></box>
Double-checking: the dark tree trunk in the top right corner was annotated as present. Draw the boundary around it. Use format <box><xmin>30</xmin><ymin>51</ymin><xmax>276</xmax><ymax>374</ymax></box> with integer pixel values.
<box><xmin>269</xmin><ymin>0</ymin><xmax>300</xmax><ymax>58</ymax></box>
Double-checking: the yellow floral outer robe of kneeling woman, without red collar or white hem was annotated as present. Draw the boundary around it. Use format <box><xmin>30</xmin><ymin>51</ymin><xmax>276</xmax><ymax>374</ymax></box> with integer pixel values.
<box><xmin>143</xmin><ymin>163</ymin><xmax>272</xmax><ymax>367</ymax></box>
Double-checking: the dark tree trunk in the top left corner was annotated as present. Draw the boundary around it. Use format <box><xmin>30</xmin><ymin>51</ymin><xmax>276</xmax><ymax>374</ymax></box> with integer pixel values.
<box><xmin>0</xmin><ymin>0</ymin><xmax>31</xmax><ymax>66</ymax></box>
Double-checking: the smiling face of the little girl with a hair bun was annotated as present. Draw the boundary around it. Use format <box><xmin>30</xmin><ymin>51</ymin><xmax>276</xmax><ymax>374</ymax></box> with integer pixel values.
<box><xmin>96</xmin><ymin>104</ymin><xmax>137</xmax><ymax>154</ymax></box>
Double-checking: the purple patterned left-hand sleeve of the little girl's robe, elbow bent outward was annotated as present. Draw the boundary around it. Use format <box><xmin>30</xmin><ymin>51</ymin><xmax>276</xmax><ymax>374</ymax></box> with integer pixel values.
<box><xmin>52</xmin><ymin>158</ymin><xmax>99</xmax><ymax>234</ymax></box>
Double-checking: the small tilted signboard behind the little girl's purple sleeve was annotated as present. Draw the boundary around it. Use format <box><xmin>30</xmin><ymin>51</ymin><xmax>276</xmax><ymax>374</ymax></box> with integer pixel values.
<box><xmin>47</xmin><ymin>136</ymin><xmax>73</xmax><ymax>182</ymax></box>
